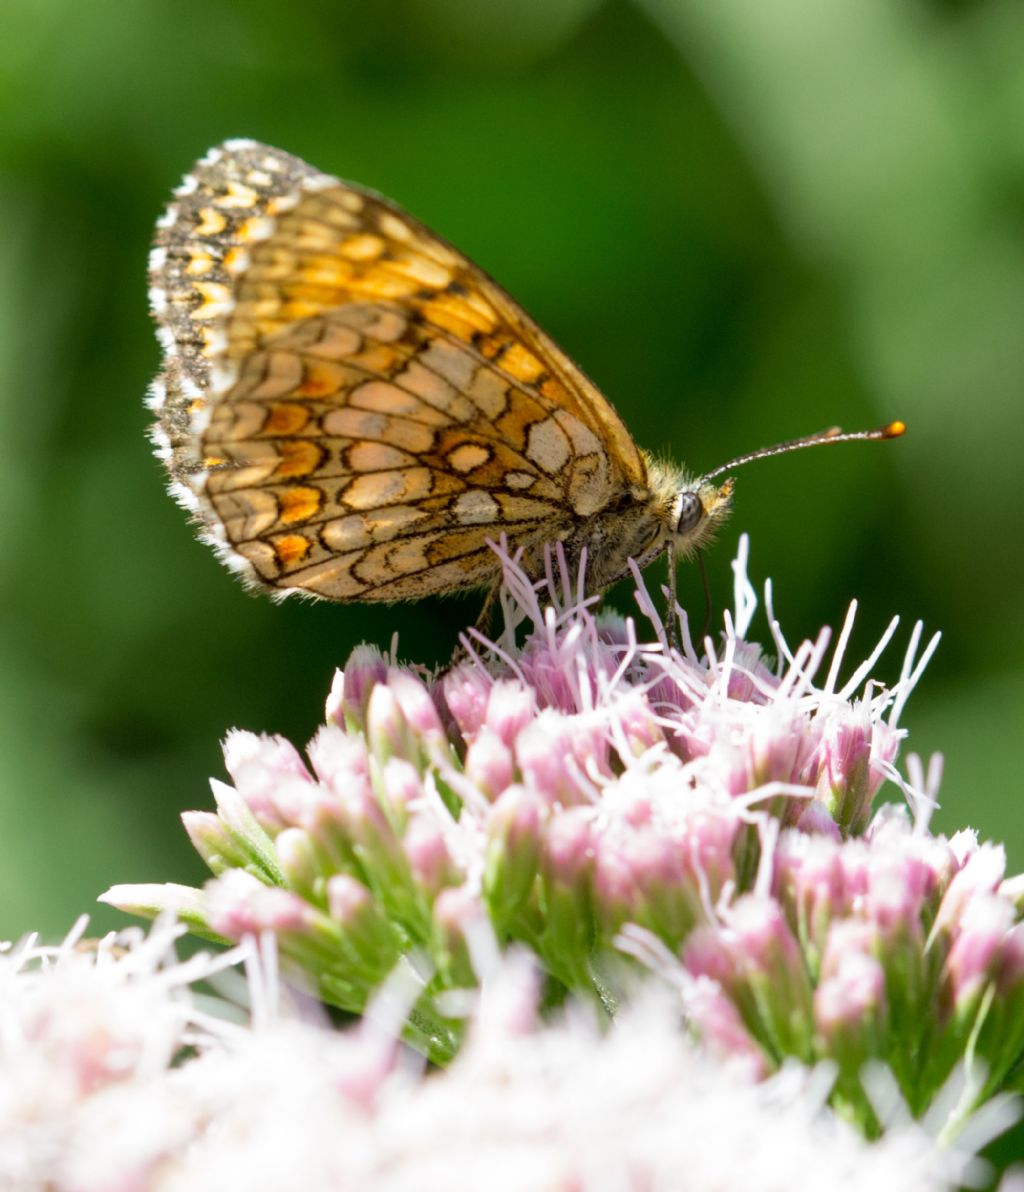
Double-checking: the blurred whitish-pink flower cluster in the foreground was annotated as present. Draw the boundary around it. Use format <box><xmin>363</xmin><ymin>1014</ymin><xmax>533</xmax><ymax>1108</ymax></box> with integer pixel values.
<box><xmin>0</xmin><ymin>923</ymin><xmax>982</xmax><ymax>1192</ymax></box>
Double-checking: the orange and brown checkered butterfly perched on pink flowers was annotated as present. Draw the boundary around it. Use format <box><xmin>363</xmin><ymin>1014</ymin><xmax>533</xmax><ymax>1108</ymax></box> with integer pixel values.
<box><xmin>149</xmin><ymin>139</ymin><xmax>902</xmax><ymax>624</ymax></box>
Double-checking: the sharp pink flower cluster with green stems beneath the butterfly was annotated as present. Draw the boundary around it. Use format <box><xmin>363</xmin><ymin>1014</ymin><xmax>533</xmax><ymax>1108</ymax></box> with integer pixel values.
<box><xmin>106</xmin><ymin>541</ymin><xmax>1024</xmax><ymax>1132</ymax></box>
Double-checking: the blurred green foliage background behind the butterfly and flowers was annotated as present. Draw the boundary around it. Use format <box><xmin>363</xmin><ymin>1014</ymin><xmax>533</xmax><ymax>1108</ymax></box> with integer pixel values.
<box><xmin>0</xmin><ymin>0</ymin><xmax>1024</xmax><ymax>936</ymax></box>
